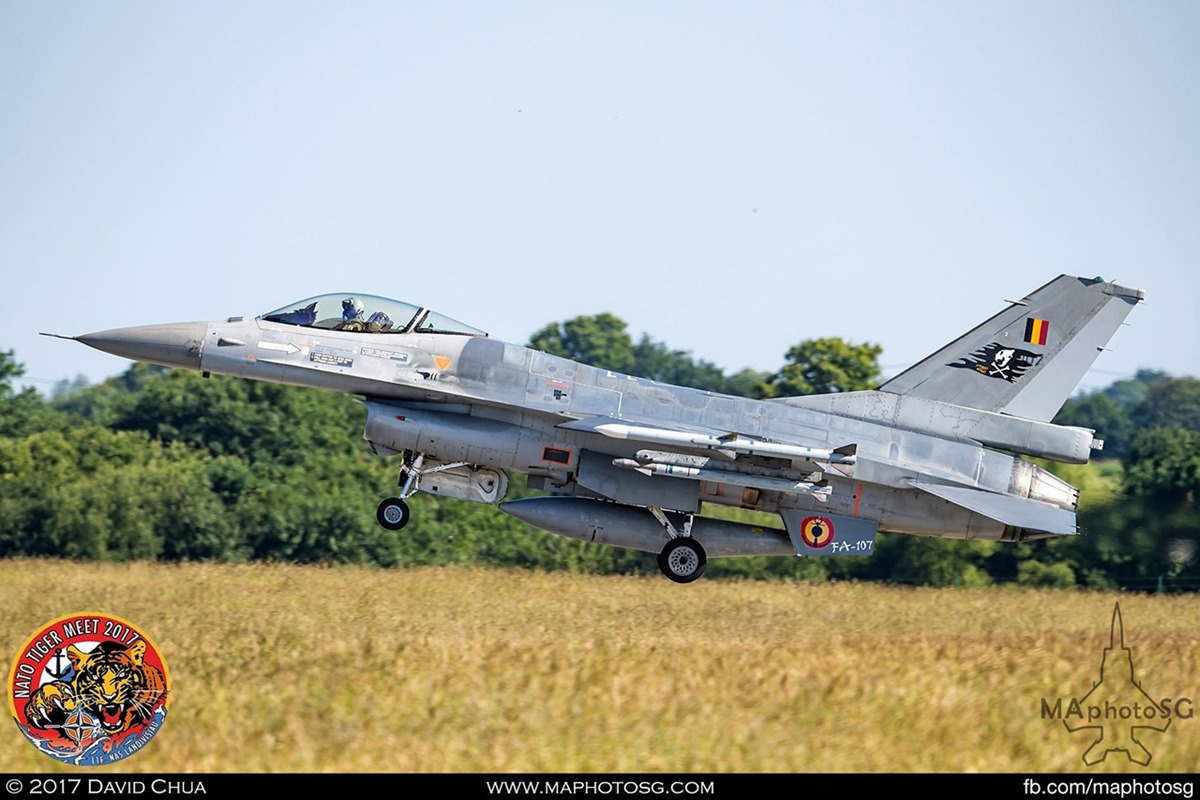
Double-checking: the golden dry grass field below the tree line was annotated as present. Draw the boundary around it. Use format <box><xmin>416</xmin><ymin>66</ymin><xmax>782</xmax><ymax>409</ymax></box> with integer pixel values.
<box><xmin>0</xmin><ymin>560</ymin><xmax>1200</xmax><ymax>774</ymax></box>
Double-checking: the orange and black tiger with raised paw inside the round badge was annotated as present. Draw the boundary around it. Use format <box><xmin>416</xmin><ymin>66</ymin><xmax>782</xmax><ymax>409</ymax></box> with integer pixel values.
<box><xmin>25</xmin><ymin>639</ymin><xmax>167</xmax><ymax>735</ymax></box>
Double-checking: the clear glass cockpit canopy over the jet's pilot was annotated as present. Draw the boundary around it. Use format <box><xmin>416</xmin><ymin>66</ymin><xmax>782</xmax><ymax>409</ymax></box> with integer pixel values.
<box><xmin>258</xmin><ymin>294</ymin><xmax>487</xmax><ymax>336</ymax></box>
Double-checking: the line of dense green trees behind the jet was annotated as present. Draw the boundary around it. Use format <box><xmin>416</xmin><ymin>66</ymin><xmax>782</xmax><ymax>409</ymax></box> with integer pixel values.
<box><xmin>0</xmin><ymin>313</ymin><xmax>1200</xmax><ymax>590</ymax></box>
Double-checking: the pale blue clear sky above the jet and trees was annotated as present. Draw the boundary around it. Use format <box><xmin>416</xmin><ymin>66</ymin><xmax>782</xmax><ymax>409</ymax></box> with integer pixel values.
<box><xmin>0</xmin><ymin>0</ymin><xmax>1200</xmax><ymax>398</ymax></box>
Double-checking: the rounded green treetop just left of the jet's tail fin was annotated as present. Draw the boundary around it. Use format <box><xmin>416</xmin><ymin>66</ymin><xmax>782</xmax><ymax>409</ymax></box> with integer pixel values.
<box><xmin>772</xmin><ymin>337</ymin><xmax>883</xmax><ymax>397</ymax></box>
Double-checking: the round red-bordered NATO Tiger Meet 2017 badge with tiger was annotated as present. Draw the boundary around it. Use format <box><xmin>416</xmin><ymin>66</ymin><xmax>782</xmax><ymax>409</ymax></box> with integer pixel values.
<box><xmin>8</xmin><ymin>612</ymin><xmax>170</xmax><ymax>766</ymax></box>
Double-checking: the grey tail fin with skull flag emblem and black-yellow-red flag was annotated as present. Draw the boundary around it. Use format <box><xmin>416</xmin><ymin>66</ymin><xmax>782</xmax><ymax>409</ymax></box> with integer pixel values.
<box><xmin>880</xmin><ymin>275</ymin><xmax>1146</xmax><ymax>422</ymax></box>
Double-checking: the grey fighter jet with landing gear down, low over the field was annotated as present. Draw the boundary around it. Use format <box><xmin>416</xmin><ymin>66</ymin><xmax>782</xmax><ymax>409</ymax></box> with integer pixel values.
<box><xmin>50</xmin><ymin>275</ymin><xmax>1145</xmax><ymax>583</ymax></box>
